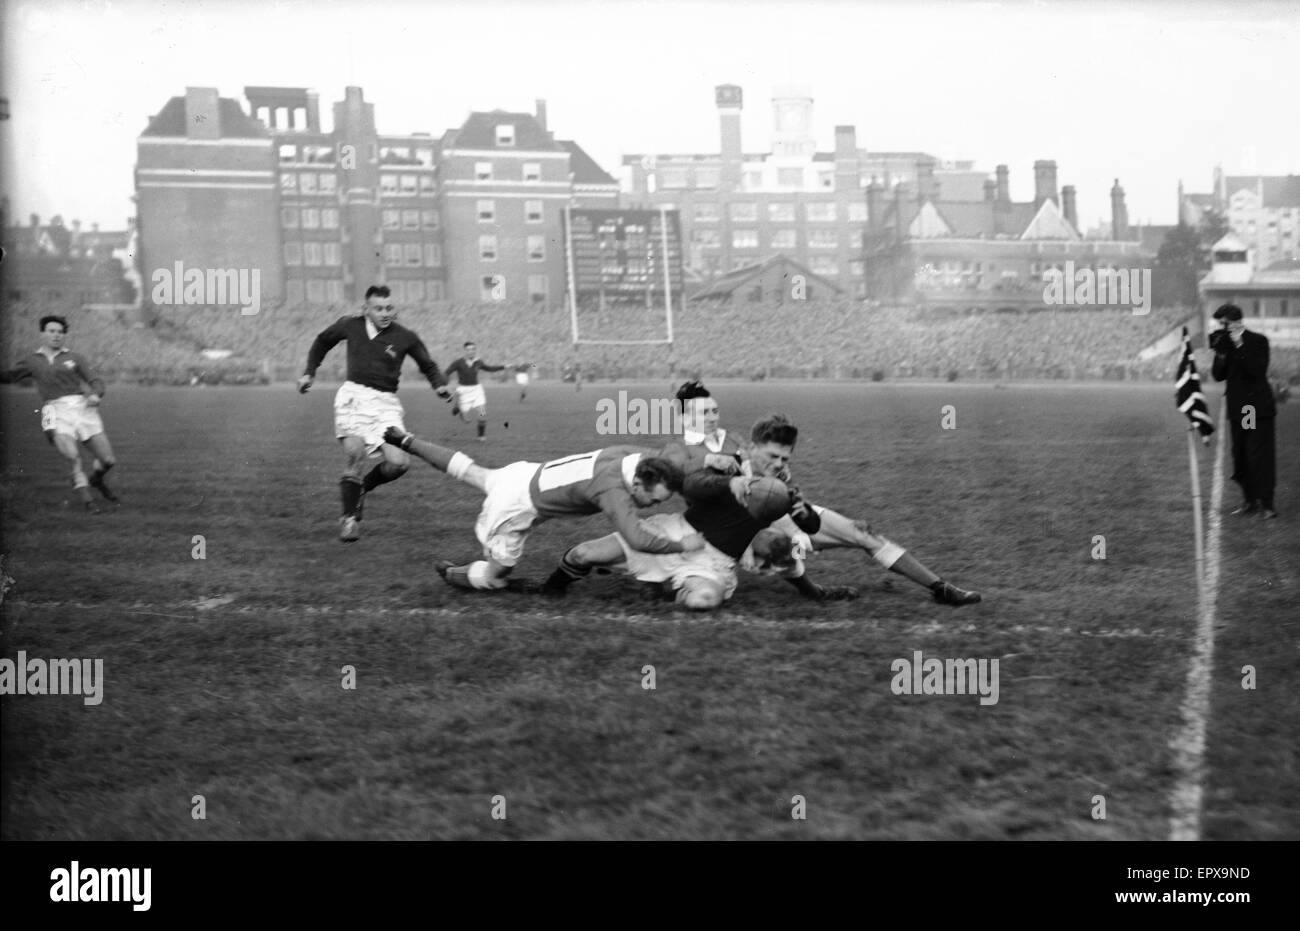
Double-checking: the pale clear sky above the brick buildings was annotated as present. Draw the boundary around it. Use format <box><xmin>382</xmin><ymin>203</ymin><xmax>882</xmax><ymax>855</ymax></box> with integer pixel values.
<box><xmin>0</xmin><ymin>0</ymin><xmax>1300</xmax><ymax>229</ymax></box>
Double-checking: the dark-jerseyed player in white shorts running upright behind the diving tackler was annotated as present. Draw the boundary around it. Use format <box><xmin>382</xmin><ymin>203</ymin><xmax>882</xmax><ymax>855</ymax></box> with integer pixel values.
<box><xmin>298</xmin><ymin>285</ymin><xmax>451</xmax><ymax>544</ymax></box>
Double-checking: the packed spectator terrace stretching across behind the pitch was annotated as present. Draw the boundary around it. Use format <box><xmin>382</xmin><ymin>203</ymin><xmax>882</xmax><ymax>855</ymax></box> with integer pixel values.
<box><xmin>3</xmin><ymin>302</ymin><xmax>1300</xmax><ymax>385</ymax></box>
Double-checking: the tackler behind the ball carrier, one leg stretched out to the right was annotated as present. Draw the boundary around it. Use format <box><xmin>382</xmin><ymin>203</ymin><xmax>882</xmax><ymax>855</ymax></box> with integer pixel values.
<box><xmin>685</xmin><ymin>386</ymin><xmax>982</xmax><ymax>607</ymax></box>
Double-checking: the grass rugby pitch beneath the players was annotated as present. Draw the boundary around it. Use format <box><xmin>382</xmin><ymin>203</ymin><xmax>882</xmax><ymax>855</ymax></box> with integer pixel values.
<box><xmin>0</xmin><ymin>380</ymin><xmax>1300</xmax><ymax>840</ymax></box>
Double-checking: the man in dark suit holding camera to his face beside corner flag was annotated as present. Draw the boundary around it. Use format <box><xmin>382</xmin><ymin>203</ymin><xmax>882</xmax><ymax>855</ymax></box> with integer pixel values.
<box><xmin>1209</xmin><ymin>304</ymin><xmax>1278</xmax><ymax>520</ymax></box>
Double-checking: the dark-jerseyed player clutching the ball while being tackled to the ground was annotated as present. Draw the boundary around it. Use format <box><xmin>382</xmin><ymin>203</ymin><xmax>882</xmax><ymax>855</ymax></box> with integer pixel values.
<box><xmin>543</xmin><ymin>410</ymin><xmax>858</xmax><ymax>611</ymax></box>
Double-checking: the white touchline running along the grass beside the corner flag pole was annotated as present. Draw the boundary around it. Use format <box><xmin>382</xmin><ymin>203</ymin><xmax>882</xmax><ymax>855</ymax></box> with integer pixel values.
<box><xmin>1169</xmin><ymin>400</ymin><xmax>1229</xmax><ymax>840</ymax></box>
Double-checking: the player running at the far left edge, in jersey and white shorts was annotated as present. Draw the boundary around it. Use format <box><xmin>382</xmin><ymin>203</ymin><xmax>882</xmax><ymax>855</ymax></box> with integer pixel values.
<box><xmin>0</xmin><ymin>315</ymin><xmax>117</xmax><ymax>511</ymax></box>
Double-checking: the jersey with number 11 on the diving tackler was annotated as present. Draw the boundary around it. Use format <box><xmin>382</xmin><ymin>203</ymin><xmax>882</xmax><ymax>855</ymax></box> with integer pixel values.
<box><xmin>528</xmin><ymin>446</ymin><xmax>683</xmax><ymax>553</ymax></box>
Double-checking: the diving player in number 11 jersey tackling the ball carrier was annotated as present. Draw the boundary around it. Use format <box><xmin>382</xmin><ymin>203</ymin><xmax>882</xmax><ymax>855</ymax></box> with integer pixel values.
<box><xmin>385</xmin><ymin>429</ymin><xmax>705</xmax><ymax>589</ymax></box>
